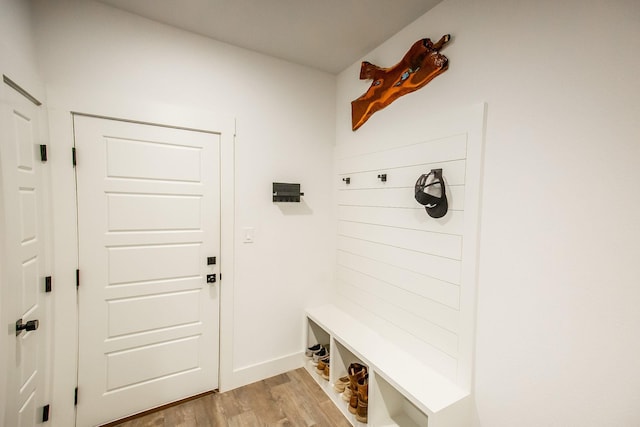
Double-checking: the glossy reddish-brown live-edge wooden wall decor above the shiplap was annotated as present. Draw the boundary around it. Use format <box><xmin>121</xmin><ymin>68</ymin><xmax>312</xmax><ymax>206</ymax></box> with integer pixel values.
<box><xmin>351</xmin><ymin>34</ymin><xmax>451</xmax><ymax>131</ymax></box>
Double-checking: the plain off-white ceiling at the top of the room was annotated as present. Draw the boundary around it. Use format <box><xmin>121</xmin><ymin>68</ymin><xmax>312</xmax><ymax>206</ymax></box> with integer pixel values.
<box><xmin>100</xmin><ymin>0</ymin><xmax>441</xmax><ymax>73</ymax></box>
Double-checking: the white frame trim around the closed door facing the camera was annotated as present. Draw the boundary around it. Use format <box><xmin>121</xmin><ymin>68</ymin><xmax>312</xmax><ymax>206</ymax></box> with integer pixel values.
<box><xmin>48</xmin><ymin>91</ymin><xmax>235</xmax><ymax>427</ymax></box>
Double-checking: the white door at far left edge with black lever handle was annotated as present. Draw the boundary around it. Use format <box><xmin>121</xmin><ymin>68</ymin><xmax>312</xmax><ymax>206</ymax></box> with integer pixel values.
<box><xmin>0</xmin><ymin>83</ymin><xmax>50</xmax><ymax>427</ymax></box>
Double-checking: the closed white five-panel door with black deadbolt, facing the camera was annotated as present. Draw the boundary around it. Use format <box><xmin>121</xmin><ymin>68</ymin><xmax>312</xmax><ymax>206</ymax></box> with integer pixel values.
<box><xmin>74</xmin><ymin>115</ymin><xmax>220</xmax><ymax>426</ymax></box>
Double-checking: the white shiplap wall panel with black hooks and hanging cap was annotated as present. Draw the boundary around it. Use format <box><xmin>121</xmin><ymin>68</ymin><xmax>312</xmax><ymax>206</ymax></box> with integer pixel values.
<box><xmin>336</xmin><ymin>106</ymin><xmax>484</xmax><ymax>387</ymax></box>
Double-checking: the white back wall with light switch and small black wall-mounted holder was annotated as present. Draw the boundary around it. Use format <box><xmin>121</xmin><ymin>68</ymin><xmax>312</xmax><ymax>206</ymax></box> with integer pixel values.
<box><xmin>35</xmin><ymin>1</ymin><xmax>335</xmax><ymax>422</ymax></box>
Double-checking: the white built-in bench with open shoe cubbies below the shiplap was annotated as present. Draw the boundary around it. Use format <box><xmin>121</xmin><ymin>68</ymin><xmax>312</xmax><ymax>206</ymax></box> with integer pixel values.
<box><xmin>305</xmin><ymin>305</ymin><xmax>471</xmax><ymax>427</ymax></box>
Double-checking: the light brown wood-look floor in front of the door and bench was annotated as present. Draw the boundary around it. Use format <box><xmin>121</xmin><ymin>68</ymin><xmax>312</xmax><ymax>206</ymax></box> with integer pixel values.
<box><xmin>111</xmin><ymin>368</ymin><xmax>351</xmax><ymax>427</ymax></box>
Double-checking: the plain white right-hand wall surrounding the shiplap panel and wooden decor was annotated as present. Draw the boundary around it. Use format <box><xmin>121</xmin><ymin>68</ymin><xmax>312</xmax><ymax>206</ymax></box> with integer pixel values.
<box><xmin>336</xmin><ymin>0</ymin><xmax>640</xmax><ymax>427</ymax></box>
